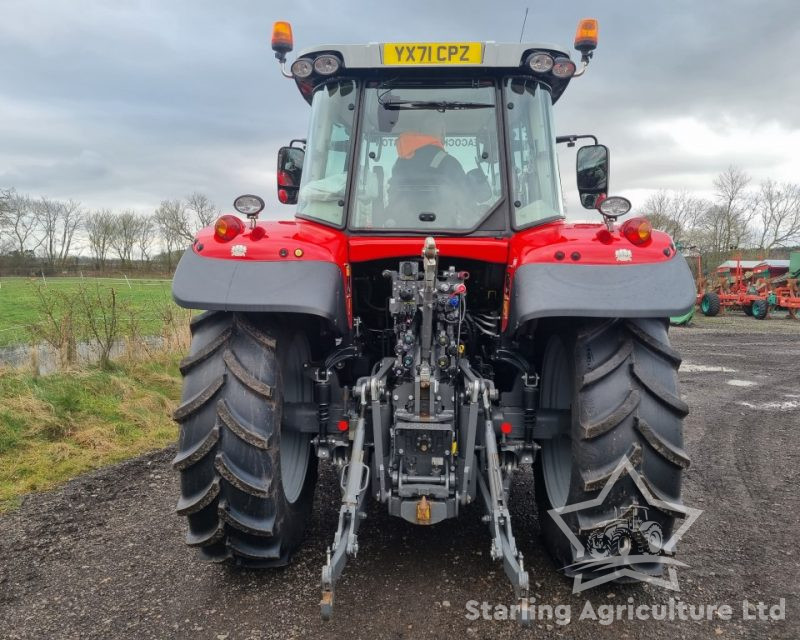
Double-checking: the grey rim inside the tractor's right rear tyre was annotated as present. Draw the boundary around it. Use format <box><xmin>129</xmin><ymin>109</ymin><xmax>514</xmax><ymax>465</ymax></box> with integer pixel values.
<box><xmin>540</xmin><ymin>337</ymin><xmax>572</xmax><ymax>507</ymax></box>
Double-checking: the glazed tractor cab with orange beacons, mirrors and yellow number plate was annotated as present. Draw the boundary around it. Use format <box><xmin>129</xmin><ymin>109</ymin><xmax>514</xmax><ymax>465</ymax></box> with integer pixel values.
<box><xmin>273</xmin><ymin>20</ymin><xmax>620</xmax><ymax>236</ymax></box>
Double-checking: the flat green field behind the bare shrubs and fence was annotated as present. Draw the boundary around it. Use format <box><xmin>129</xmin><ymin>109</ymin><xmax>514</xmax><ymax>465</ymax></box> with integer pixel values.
<box><xmin>0</xmin><ymin>278</ymin><xmax>173</xmax><ymax>346</ymax></box>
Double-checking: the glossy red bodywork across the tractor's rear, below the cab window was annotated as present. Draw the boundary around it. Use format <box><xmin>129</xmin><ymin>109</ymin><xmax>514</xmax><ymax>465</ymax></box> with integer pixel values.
<box><xmin>194</xmin><ymin>220</ymin><xmax>675</xmax><ymax>330</ymax></box>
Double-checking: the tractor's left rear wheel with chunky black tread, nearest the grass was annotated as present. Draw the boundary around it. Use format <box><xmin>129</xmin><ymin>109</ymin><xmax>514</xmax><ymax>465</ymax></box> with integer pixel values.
<box><xmin>173</xmin><ymin>312</ymin><xmax>316</xmax><ymax>567</ymax></box>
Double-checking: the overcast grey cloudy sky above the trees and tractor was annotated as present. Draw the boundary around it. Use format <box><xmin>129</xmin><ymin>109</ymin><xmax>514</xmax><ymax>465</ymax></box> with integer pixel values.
<box><xmin>0</xmin><ymin>0</ymin><xmax>800</xmax><ymax>217</ymax></box>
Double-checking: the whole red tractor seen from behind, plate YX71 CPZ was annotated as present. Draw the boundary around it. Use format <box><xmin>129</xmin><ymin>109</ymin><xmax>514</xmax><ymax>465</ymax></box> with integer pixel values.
<box><xmin>173</xmin><ymin>20</ymin><xmax>694</xmax><ymax>618</ymax></box>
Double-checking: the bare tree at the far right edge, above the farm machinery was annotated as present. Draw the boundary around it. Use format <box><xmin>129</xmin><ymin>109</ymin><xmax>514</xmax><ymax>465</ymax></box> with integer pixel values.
<box><xmin>755</xmin><ymin>180</ymin><xmax>800</xmax><ymax>250</ymax></box>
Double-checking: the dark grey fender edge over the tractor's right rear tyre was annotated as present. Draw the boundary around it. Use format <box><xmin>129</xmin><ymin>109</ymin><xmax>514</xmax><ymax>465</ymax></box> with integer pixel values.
<box><xmin>508</xmin><ymin>255</ymin><xmax>695</xmax><ymax>332</ymax></box>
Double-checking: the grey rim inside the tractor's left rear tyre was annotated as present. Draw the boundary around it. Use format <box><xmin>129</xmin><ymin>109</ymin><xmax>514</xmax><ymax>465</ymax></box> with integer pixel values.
<box><xmin>280</xmin><ymin>334</ymin><xmax>311</xmax><ymax>503</ymax></box>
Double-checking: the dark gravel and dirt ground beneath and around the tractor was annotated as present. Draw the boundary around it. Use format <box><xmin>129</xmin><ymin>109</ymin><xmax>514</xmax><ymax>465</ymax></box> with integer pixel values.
<box><xmin>0</xmin><ymin>317</ymin><xmax>800</xmax><ymax>640</ymax></box>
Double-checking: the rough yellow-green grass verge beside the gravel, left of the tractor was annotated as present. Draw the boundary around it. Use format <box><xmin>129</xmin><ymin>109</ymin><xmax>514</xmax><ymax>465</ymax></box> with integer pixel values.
<box><xmin>0</xmin><ymin>355</ymin><xmax>180</xmax><ymax>512</ymax></box>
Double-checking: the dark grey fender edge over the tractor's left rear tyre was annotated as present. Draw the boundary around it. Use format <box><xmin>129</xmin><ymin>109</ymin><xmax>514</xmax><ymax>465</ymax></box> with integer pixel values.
<box><xmin>172</xmin><ymin>248</ymin><xmax>348</xmax><ymax>333</ymax></box>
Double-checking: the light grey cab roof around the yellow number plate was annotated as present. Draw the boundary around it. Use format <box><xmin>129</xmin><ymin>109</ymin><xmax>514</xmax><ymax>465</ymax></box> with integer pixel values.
<box><xmin>295</xmin><ymin>41</ymin><xmax>570</xmax><ymax>103</ymax></box>
